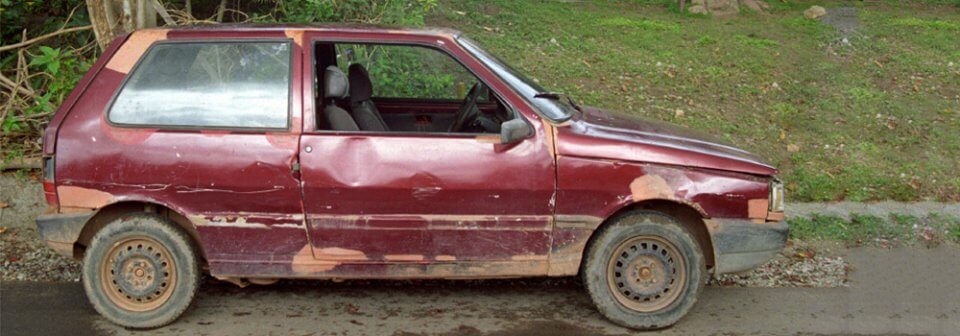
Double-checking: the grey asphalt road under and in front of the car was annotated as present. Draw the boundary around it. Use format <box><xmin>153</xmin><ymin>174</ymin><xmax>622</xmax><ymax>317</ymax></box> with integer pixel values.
<box><xmin>0</xmin><ymin>248</ymin><xmax>960</xmax><ymax>336</ymax></box>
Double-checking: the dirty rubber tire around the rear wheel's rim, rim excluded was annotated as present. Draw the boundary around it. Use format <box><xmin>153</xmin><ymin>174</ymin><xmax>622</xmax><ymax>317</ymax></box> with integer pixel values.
<box><xmin>82</xmin><ymin>213</ymin><xmax>201</xmax><ymax>329</ymax></box>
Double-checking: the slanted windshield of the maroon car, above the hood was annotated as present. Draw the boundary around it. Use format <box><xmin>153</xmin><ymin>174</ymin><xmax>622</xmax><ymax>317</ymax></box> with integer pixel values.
<box><xmin>457</xmin><ymin>35</ymin><xmax>576</xmax><ymax>122</ymax></box>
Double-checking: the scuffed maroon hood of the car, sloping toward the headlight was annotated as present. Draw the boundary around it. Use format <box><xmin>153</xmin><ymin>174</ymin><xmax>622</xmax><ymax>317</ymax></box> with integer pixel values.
<box><xmin>557</xmin><ymin>107</ymin><xmax>777</xmax><ymax>175</ymax></box>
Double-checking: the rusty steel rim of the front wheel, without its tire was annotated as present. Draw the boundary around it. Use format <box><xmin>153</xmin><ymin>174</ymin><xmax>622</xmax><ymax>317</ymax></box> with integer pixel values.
<box><xmin>607</xmin><ymin>236</ymin><xmax>687</xmax><ymax>312</ymax></box>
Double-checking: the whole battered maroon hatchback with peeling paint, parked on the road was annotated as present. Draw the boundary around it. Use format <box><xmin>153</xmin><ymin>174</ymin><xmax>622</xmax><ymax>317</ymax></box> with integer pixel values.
<box><xmin>37</xmin><ymin>25</ymin><xmax>788</xmax><ymax>329</ymax></box>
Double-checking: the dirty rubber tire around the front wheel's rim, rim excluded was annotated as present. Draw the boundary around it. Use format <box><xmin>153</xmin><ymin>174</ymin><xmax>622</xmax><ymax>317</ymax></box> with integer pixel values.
<box><xmin>580</xmin><ymin>210</ymin><xmax>707</xmax><ymax>330</ymax></box>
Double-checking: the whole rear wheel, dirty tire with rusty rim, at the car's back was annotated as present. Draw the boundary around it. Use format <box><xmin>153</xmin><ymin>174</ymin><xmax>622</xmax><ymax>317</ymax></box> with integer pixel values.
<box><xmin>83</xmin><ymin>213</ymin><xmax>200</xmax><ymax>329</ymax></box>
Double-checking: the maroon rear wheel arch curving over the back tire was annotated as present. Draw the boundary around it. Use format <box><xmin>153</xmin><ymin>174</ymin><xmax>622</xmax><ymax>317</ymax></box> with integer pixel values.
<box><xmin>73</xmin><ymin>201</ymin><xmax>207</xmax><ymax>266</ymax></box>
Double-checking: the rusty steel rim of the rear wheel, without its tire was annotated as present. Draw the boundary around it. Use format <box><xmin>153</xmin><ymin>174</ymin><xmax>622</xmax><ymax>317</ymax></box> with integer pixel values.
<box><xmin>100</xmin><ymin>236</ymin><xmax>177</xmax><ymax>312</ymax></box>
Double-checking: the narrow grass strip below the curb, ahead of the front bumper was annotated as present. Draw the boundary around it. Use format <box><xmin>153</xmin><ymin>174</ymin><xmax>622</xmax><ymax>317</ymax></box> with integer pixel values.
<box><xmin>787</xmin><ymin>213</ymin><xmax>960</xmax><ymax>246</ymax></box>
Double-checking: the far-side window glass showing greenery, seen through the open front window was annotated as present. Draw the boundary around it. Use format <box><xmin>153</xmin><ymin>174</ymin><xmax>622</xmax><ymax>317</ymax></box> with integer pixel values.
<box><xmin>337</xmin><ymin>44</ymin><xmax>477</xmax><ymax>100</ymax></box>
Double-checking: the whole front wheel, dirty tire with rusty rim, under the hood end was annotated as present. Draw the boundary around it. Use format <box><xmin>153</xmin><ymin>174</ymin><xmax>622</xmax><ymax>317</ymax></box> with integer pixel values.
<box><xmin>580</xmin><ymin>211</ymin><xmax>706</xmax><ymax>330</ymax></box>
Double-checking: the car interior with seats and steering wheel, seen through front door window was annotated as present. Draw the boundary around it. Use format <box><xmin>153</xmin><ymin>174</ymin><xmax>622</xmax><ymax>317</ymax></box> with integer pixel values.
<box><xmin>314</xmin><ymin>42</ymin><xmax>515</xmax><ymax>134</ymax></box>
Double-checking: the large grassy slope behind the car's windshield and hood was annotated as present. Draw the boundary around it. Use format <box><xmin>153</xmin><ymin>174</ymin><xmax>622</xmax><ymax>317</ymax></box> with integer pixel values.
<box><xmin>436</xmin><ymin>0</ymin><xmax>960</xmax><ymax>202</ymax></box>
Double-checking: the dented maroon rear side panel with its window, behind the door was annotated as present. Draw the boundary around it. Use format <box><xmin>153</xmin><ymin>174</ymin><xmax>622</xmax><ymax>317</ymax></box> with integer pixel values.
<box><xmin>56</xmin><ymin>36</ymin><xmax>307</xmax><ymax>275</ymax></box>
